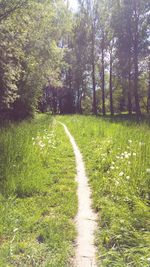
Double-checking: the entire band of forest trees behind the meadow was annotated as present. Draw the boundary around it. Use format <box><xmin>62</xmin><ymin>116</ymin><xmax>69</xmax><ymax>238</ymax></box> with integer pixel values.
<box><xmin>0</xmin><ymin>0</ymin><xmax>150</xmax><ymax>120</ymax></box>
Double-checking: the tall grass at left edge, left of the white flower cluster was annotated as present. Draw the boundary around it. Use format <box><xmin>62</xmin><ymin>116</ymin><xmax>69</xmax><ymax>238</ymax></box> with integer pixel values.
<box><xmin>0</xmin><ymin>116</ymin><xmax>52</xmax><ymax>197</ymax></box>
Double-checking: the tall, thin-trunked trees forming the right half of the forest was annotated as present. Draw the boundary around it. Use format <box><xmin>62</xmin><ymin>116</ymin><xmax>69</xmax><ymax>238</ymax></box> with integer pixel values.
<box><xmin>64</xmin><ymin>0</ymin><xmax>150</xmax><ymax>116</ymax></box>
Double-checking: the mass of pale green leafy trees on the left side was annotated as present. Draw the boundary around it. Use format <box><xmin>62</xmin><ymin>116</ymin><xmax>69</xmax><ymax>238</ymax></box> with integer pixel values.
<box><xmin>0</xmin><ymin>0</ymin><xmax>71</xmax><ymax>119</ymax></box>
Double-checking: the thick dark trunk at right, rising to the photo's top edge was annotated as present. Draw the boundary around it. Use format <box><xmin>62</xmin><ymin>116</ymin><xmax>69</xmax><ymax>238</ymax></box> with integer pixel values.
<box><xmin>133</xmin><ymin>0</ymin><xmax>141</xmax><ymax>119</ymax></box>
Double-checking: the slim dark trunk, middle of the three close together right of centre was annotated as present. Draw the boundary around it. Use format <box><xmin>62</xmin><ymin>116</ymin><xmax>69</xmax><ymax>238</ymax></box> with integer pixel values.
<box><xmin>102</xmin><ymin>30</ymin><xmax>106</xmax><ymax>116</ymax></box>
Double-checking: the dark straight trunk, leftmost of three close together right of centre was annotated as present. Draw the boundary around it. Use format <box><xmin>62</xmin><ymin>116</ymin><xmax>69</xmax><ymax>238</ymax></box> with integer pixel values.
<box><xmin>92</xmin><ymin>25</ymin><xmax>97</xmax><ymax>115</ymax></box>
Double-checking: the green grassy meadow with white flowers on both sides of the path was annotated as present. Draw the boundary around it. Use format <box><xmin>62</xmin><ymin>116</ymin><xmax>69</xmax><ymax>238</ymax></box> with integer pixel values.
<box><xmin>0</xmin><ymin>115</ymin><xmax>150</xmax><ymax>267</ymax></box>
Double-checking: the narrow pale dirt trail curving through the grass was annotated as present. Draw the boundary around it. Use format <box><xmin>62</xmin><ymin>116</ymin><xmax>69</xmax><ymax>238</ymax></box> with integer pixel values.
<box><xmin>60</xmin><ymin>122</ymin><xmax>97</xmax><ymax>267</ymax></box>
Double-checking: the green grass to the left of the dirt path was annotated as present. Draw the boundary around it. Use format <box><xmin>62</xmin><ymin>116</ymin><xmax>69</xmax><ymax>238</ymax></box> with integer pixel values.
<box><xmin>0</xmin><ymin>115</ymin><xmax>77</xmax><ymax>267</ymax></box>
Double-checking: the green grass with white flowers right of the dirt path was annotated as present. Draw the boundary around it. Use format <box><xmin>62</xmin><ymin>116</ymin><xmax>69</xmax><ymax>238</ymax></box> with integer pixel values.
<box><xmin>61</xmin><ymin>116</ymin><xmax>150</xmax><ymax>267</ymax></box>
